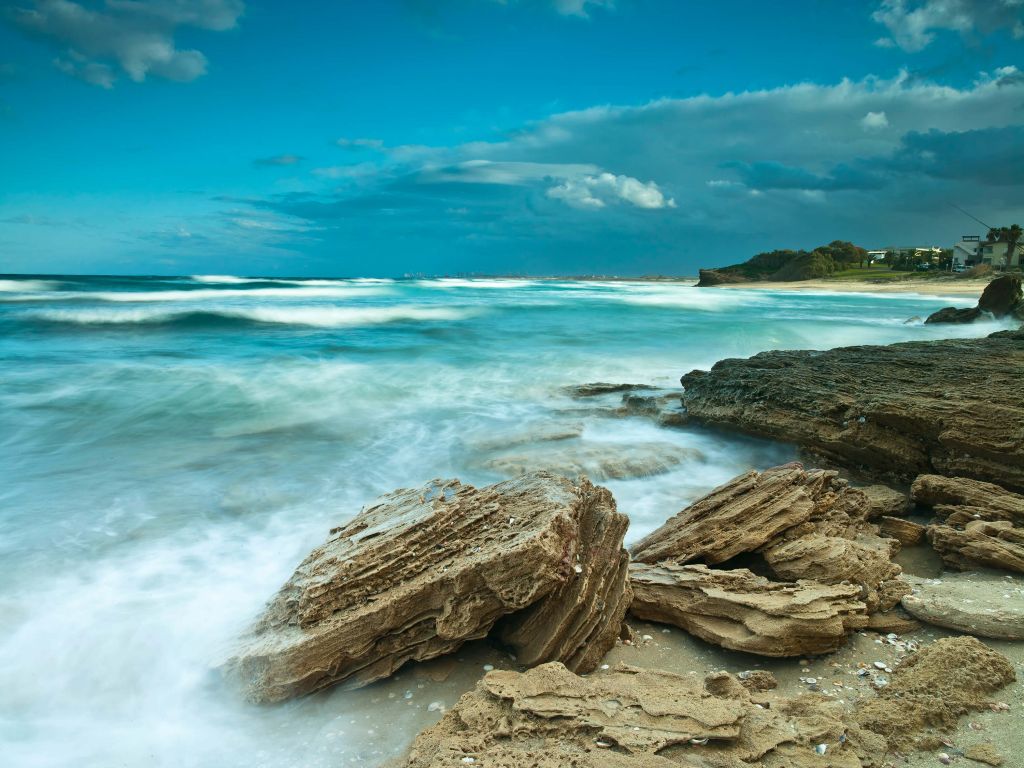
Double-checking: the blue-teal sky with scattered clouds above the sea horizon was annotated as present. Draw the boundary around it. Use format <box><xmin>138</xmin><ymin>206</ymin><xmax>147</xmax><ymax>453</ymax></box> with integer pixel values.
<box><xmin>0</xmin><ymin>0</ymin><xmax>1024</xmax><ymax>276</ymax></box>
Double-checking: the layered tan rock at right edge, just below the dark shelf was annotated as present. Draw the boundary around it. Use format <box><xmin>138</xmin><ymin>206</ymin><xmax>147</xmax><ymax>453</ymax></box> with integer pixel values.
<box><xmin>911</xmin><ymin>475</ymin><xmax>1024</xmax><ymax>573</ymax></box>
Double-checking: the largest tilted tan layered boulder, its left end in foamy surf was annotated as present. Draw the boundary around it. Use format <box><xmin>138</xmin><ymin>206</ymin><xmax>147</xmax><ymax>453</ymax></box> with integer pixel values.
<box><xmin>226</xmin><ymin>473</ymin><xmax>630</xmax><ymax>701</ymax></box>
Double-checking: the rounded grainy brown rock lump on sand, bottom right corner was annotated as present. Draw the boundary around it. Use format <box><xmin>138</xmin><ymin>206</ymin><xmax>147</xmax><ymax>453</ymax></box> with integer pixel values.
<box><xmin>855</xmin><ymin>637</ymin><xmax>1017</xmax><ymax>752</ymax></box>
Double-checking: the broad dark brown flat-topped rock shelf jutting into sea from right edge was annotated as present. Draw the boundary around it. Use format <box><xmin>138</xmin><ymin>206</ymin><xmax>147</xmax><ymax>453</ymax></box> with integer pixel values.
<box><xmin>682</xmin><ymin>331</ymin><xmax>1024</xmax><ymax>488</ymax></box>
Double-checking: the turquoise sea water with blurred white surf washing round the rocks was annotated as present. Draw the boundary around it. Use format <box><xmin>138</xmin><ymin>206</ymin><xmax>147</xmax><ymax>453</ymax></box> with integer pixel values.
<box><xmin>0</xmin><ymin>275</ymin><xmax>997</xmax><ymax>768</ymax></box>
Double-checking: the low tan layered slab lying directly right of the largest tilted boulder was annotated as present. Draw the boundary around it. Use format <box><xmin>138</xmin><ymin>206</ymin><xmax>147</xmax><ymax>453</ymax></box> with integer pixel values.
<box><xmin>630</xmin><ymin>563</ymin><xmax>867</xmax><ymax>656</ymax></box>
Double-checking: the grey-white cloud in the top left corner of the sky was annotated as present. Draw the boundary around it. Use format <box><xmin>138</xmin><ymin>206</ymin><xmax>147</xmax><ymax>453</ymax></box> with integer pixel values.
<box><xmin>11</xmin><ymin>0</ymin><xmax>245</xmax><ymax>88</ymax></box>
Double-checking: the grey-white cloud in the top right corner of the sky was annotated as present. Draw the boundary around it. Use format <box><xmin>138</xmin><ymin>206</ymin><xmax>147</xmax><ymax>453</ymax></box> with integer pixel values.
<box><xmin>871</xmin><ymin>0</ymin><xmax>1024</xmax><ymax>52</ymax></box>
